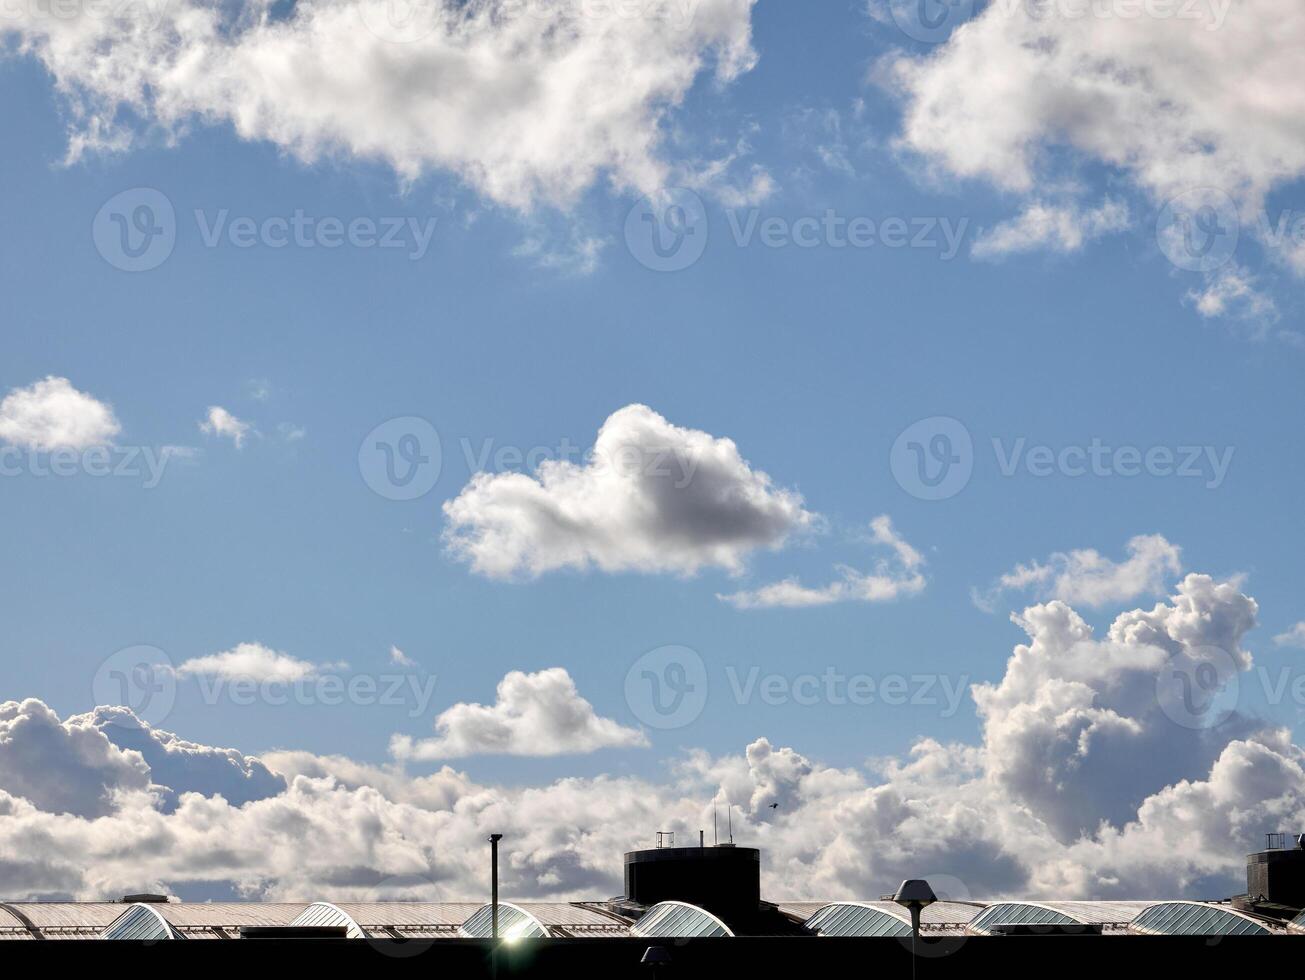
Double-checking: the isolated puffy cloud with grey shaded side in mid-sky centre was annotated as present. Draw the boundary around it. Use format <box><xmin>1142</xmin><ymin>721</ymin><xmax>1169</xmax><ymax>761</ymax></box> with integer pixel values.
<box><xmin>444</xmin><ymin>405</ymin><xmax>816</xmax><ymax>578</ymax></box>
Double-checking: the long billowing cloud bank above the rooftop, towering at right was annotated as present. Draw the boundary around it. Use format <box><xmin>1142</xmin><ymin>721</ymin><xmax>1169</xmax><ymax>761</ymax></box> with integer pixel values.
<box><xmin>0</xmin><ymin>575</ymin><xmax>1305</xmax><ymax>900</ymax></box>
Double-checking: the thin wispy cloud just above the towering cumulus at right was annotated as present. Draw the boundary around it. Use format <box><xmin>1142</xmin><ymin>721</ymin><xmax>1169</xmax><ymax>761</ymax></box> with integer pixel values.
<box><xmin>974</xmin><ymin>534</ymin><xmax>1182</xmax><ymax>612</ymax></box>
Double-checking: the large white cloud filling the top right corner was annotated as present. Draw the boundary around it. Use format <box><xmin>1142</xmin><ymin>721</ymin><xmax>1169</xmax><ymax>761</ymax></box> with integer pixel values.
<box><xmin>892</xmin><ymin>0</ymin><xmax>1305</xmax><ymax>289</ymax></box>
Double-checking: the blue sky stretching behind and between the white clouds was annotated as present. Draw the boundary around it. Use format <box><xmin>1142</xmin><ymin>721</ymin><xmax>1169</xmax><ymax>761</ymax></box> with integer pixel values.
<box><xmin>0</xmin><ymin>0</ymin><xmax>1305</xmax><ymax>903</ymax></box>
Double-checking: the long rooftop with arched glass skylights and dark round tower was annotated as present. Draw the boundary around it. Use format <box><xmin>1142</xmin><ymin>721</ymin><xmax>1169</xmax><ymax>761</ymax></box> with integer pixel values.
<box><xmin>0</xmin><ymin>834</ymin><xmax>1305</xmax><ymax>941</ymax></box>
